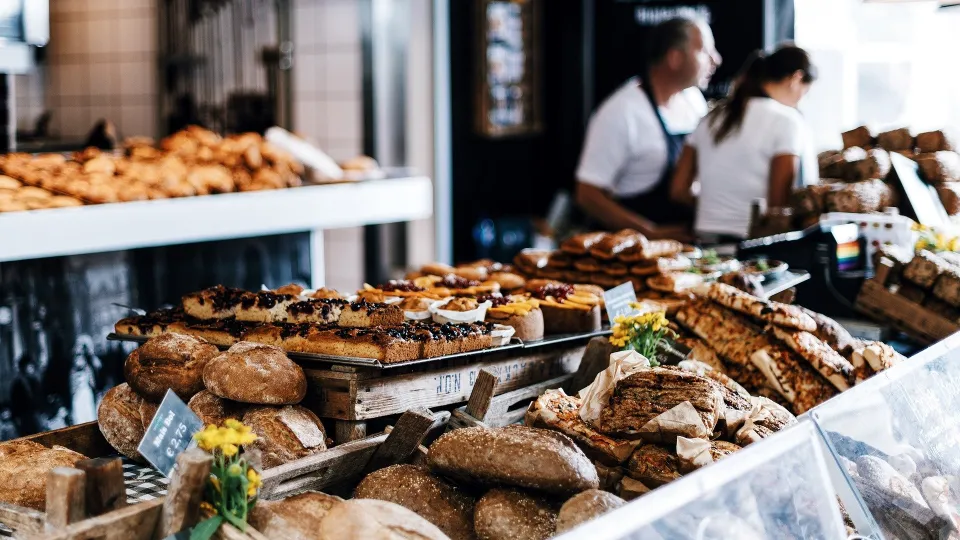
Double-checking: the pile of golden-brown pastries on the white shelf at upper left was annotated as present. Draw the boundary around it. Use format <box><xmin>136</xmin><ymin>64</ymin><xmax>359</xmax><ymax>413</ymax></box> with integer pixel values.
<box><xmin>0</xmin><ymin>126</ymin><xmax>303</xmax><ymax>210</ymax></box>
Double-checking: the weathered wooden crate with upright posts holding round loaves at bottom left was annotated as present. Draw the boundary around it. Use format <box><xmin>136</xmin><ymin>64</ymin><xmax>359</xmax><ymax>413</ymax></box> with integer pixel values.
<box><xmin>0</xmin><ymin>409</ymin><xmax>442</xmax><ymax>540</ymax></box>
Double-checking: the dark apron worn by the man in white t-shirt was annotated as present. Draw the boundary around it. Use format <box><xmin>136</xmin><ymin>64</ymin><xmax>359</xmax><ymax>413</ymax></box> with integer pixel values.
<box><xmin>617</xmin><ymin>79</ymin><xmax>694</xmax><ymax>225</ymax></box>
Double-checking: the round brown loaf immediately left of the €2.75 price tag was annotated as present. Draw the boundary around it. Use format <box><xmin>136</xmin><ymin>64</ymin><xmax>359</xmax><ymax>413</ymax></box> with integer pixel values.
<box><xmin>97</xmin><ymin>383</ymin><xmax>156</xmax><ymax>461</ymax></box>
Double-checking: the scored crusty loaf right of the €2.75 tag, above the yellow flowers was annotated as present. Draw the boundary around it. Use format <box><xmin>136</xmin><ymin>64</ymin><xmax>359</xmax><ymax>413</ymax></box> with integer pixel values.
<box><xmin>243</xmin><ymin>405</ymin><xmax>327</xmax><ymax>469</ymax></box>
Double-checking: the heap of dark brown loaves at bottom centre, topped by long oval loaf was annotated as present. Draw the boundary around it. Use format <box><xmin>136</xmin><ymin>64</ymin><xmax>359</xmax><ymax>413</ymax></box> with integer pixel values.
<box><xmin>251</xmin><ymin>426</ymin><xmax>625</xmax><ymax>540</ymax></box>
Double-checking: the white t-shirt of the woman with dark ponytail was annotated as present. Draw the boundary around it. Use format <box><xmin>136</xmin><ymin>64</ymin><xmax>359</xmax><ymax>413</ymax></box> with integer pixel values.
<box><xmin>687</xmin><ymin>98</ymin><xmax>820</xmax><ymax>237</ymax></box>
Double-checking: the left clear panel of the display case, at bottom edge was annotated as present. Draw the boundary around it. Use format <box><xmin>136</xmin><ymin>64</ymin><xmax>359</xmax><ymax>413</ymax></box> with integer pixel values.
<box><xmin>558</xmin><ymin>421</ymin><xmax>847</xmax><ymax>540</ymax></box>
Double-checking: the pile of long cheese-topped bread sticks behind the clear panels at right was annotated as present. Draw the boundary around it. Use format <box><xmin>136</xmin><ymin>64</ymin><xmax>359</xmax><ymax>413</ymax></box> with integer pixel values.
<box><xmin>676</xmin><ymin>283</ymin><xmax>903</xmax><ymax>414</ymax></box>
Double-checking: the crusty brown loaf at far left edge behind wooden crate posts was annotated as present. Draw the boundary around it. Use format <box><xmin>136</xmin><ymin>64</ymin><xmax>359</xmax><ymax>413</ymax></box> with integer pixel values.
<box><xmin>0</xmin><ymin>440</ymin><xmax>87</xmax><ymax>510</ymax></box>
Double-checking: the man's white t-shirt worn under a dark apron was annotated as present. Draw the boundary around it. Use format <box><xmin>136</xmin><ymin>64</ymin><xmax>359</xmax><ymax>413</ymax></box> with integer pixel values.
<box><xmin>577</xmin><ymin>77</ymin><xmax>707</xmax><ymax>197</ymax></box>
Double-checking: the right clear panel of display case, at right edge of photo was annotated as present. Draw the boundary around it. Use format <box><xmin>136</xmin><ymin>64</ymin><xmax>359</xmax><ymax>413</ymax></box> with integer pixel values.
<box><xmin>810</xmin><ymin>334</ymin><xmax>960</xmax><ymax>538</ymax></box>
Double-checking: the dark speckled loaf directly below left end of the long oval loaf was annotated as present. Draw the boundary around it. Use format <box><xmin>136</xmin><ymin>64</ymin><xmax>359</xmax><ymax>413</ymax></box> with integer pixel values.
<box><xmin>354</xmin><ymin>464</ymin><xmax>477</xmax><ymax>540</ymax></box>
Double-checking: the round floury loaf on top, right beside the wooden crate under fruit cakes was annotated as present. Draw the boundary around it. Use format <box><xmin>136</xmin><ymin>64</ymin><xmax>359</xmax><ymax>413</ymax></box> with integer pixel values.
<box><xmin>203</xmin><ymin>341</ymin><xmax>307</xmax><ymax>405</ymax></box>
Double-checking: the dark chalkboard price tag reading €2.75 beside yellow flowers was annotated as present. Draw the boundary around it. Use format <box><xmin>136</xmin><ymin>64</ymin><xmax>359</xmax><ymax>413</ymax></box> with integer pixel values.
<box><xmin>137</xmin><ymin>390</ymin><xmax>203</xmax><ymax>478</ymax></box>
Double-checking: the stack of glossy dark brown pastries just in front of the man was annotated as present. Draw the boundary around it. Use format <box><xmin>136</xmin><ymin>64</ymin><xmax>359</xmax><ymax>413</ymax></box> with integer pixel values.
<box><xmin>514</xmin><ymin>229</ymin><xmax>703</xmax><ymax>308</ymax></box>
